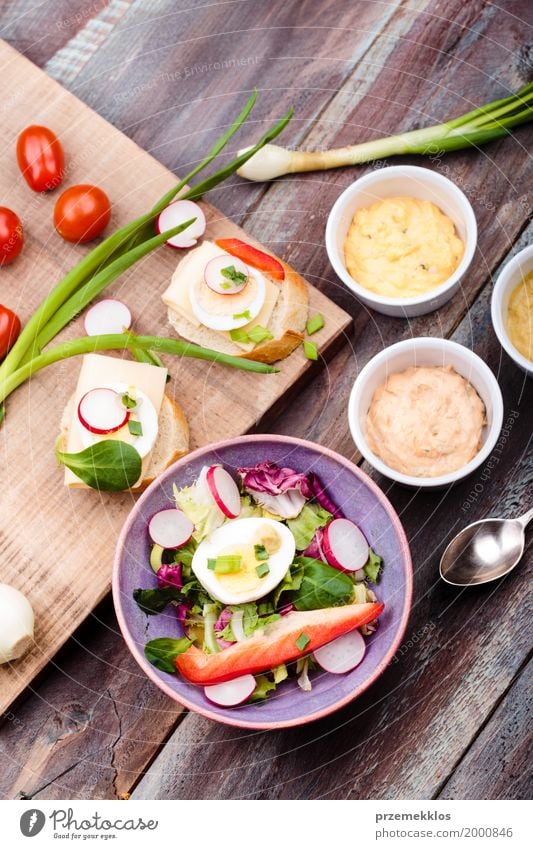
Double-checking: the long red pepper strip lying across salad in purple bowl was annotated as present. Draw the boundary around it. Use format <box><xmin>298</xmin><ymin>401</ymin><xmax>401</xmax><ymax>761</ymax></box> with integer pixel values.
<box><xmin>176</xmin><ymin>602</ymin><xmax>384</xmax><ymax>685</ymax></box>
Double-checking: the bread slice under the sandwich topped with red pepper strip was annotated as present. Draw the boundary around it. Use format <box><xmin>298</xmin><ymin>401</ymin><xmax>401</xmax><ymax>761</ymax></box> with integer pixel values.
<box><xmin>168</xmin><ymin>250</ymin><xmax>309</xmax><ymax>363</ymax></box>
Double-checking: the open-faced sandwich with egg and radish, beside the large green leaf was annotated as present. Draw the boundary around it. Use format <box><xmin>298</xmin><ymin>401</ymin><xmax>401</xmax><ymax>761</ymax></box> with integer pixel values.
<box><xmin>57</xmin><ymin>354</ymin><xmax>189</xmax><ymax>490</ymax></box>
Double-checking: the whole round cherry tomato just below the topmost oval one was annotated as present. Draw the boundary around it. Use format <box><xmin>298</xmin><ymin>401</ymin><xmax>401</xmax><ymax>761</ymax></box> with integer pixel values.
<box><xmin>54</xmin><ymin>186</ymin><xmax>111</xmax><ymax>242</ymax></box>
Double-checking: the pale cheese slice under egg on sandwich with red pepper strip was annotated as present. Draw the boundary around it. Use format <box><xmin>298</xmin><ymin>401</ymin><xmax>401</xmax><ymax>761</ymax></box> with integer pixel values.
<box><xmin>162</xmin><ymin>241</ymin><xmax>279</xmax><ymax>351</ymax></box>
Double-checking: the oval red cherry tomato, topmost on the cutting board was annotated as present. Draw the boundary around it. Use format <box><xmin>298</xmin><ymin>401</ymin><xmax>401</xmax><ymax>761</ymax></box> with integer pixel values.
<box><xmin>17</xmin><ymin>125</ymin><xmax>65</xmax><ymax>192</ymax></box>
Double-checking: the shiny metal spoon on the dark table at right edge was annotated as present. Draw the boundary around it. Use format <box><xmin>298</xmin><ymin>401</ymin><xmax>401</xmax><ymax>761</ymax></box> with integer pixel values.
<box><xmin>440</xmin><ymin>508</ymin><xmax>533</xmax><ymax>587</ymax></box>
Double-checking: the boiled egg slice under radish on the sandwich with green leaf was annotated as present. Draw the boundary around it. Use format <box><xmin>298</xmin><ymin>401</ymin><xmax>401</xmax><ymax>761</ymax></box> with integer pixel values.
<box><xmin>77</xmin><ymin>383</ymin><xmax>159</xmax><ymax>457</ymax></box>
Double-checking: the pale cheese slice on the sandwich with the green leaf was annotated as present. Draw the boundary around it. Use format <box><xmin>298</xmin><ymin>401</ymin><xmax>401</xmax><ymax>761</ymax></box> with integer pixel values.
<box><xmin>65</xmin><ymin>354</ymin><xmax>167</xmax><ymax>486</ymax></box>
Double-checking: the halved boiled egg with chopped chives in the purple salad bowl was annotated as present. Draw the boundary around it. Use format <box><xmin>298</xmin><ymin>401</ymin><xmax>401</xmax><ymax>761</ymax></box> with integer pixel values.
<box><xmin>192</xmin><ymin>518</ymin><xmax>295</xmax><ymax>604</ymax></box>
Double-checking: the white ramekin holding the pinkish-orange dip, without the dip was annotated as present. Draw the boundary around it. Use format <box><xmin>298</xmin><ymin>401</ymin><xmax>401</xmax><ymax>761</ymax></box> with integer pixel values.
<box><xmin>348</xmin><ymin>337</ymin><xmax>503</xmax><ymax>489</ymax></box>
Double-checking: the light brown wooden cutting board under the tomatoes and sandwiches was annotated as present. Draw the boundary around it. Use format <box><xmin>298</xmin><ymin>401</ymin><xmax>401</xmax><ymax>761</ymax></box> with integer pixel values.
<box><xmin>0</xmin><ymin>41</ymin><xmax>351</xmax><ymax>712</ymax></box>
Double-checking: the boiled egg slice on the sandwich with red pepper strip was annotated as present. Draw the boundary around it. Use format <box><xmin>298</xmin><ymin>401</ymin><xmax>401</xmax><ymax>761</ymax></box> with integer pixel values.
<box><xmin>189</xmin><ymin>268</ymin><xmax>266</xmax><ymax>330</ymax></box>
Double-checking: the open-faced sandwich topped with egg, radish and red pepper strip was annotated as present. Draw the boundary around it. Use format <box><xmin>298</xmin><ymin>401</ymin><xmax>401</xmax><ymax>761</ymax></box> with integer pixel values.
<box><xmin>163</xmin><ymin>239</ymin><xmax>309</xmax><ymax>363</ymax></box>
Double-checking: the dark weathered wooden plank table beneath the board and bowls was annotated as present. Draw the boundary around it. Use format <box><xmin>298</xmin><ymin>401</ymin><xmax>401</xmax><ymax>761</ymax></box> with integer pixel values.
<box><xmin>0</xmin><ymin>0</ymin><xmax>533</xmax><ymax>799</ymax></box>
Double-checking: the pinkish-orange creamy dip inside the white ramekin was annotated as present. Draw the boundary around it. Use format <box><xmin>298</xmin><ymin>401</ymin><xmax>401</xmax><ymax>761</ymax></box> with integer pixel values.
<box><xmin>366</xmin><ymin>366</ymin><xmax>486</xmax><ymax>477</ymax></box>
